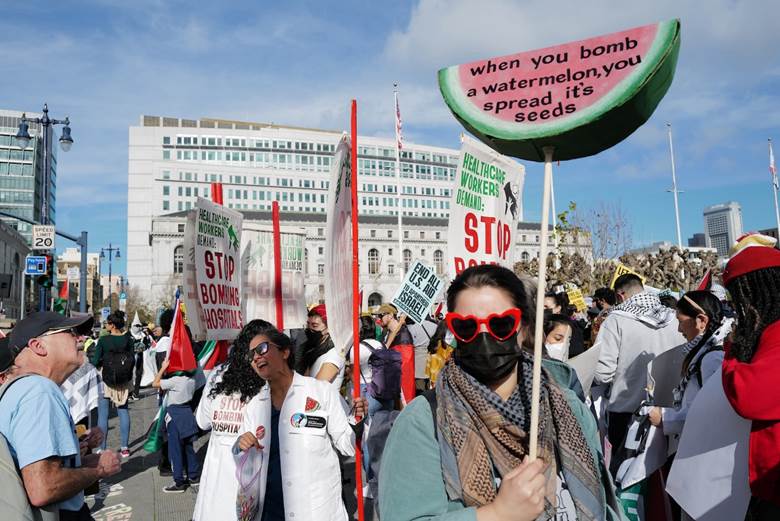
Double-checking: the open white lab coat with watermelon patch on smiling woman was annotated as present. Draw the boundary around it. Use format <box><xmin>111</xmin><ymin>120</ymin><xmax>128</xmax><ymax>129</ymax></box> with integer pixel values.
<box><xmin>242</xmin><ymin>373</ymin><xmax>355</xmax><ymax>521</ymax></box>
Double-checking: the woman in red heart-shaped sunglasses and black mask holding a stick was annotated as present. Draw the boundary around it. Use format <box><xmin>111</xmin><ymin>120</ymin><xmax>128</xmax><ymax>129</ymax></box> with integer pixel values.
<box><xmin>379</xmin><ymin>265</ymin><xmax>624</xmax><ymax>521</ymax></box>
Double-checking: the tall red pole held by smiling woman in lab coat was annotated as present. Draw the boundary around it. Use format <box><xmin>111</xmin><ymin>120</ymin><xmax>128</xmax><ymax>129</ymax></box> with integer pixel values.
<box><xmin>350</xmin><ymin>100</ymin><xmax>364</xmax><ymax>521</ymax></box>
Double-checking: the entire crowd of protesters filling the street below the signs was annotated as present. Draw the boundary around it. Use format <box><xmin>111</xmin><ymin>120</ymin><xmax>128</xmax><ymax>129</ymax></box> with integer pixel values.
<box><xmin>0</xmin><ymin>236</ymin><xmax>780</xmax><ymax>521</ymax></box>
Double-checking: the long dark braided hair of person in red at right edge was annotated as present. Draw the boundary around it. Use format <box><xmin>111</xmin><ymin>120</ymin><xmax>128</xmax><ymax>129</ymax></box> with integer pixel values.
<box><xmin>726</xmin><ymin>268</ymin><xmax>780</xmax><ymax>362</ymax></box>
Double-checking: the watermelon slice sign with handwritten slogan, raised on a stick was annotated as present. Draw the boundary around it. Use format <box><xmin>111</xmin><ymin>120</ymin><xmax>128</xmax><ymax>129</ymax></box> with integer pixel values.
<box><xmin>439</xmin><ymin>20</ymin><xmax>680</xmax><ymax>161</ymax></box>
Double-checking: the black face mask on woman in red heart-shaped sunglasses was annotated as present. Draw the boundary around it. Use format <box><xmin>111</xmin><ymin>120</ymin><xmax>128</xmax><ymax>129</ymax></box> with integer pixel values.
<box><xmin>453</xmin><ymin>333</ymin><xmax>521</xmax><ymax>385</ymax></box>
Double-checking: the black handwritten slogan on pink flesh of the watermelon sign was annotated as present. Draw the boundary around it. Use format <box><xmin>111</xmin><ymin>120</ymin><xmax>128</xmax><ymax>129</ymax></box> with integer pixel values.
<box><xmin>467</xmin><ymin>36</ymin><xmax>642</xmax><ymax>123</ymax></box>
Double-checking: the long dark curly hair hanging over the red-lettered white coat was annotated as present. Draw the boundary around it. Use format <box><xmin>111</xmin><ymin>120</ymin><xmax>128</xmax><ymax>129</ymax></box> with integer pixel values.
<box><xmin>209</xmin><ymin>319</ymin><xmax>276</xmax><ymax>403</ymax></box>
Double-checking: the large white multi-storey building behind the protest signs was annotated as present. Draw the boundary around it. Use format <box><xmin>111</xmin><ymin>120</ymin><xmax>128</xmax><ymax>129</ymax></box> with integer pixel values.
<box><xmin>127</xmin><ymin>116</ymin><xmax>590</xmax><ymax>305</ymax></box>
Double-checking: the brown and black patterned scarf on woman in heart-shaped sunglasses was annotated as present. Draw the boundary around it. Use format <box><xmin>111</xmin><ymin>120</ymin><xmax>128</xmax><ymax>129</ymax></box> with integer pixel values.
<box><xmin>436</xmin><ymin>353</ymin><xmax>604</xmax><ymax>521</ymax></box>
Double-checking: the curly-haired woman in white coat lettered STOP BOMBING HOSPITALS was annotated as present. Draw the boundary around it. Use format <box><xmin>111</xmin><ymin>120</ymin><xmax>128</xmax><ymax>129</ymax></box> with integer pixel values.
<box><xmin>192</xmin><ymin>320</ymin><xmax>273</xmax><ymax>521</ymax></box>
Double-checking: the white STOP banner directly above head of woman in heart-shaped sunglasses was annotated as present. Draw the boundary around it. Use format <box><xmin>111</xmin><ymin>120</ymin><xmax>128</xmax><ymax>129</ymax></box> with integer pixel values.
<box><xmin>447</xmin><ymin>136</ymin><xmax>525</xmax><ymax>275</ymax></box>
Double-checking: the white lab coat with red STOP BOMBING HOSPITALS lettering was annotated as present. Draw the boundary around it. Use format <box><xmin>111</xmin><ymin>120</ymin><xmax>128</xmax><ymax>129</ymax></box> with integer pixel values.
<box><xmin>192</xmin><ymin>368</ymin><xmax>247</xmax><ymax>521</ymax></box>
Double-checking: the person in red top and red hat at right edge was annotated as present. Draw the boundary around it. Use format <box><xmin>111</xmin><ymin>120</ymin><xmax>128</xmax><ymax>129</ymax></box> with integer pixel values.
<box><xmin>723</xmin><ymin>234</ymin><xmax>780</xmax><ymax>521</ymax></box>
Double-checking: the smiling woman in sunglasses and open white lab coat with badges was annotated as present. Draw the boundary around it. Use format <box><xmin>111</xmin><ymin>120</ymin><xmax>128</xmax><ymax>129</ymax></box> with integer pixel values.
<box><xmin>238</xmin><ymin>324</ymin><xmax>367</xmax><ymax>521</ymax></box>
